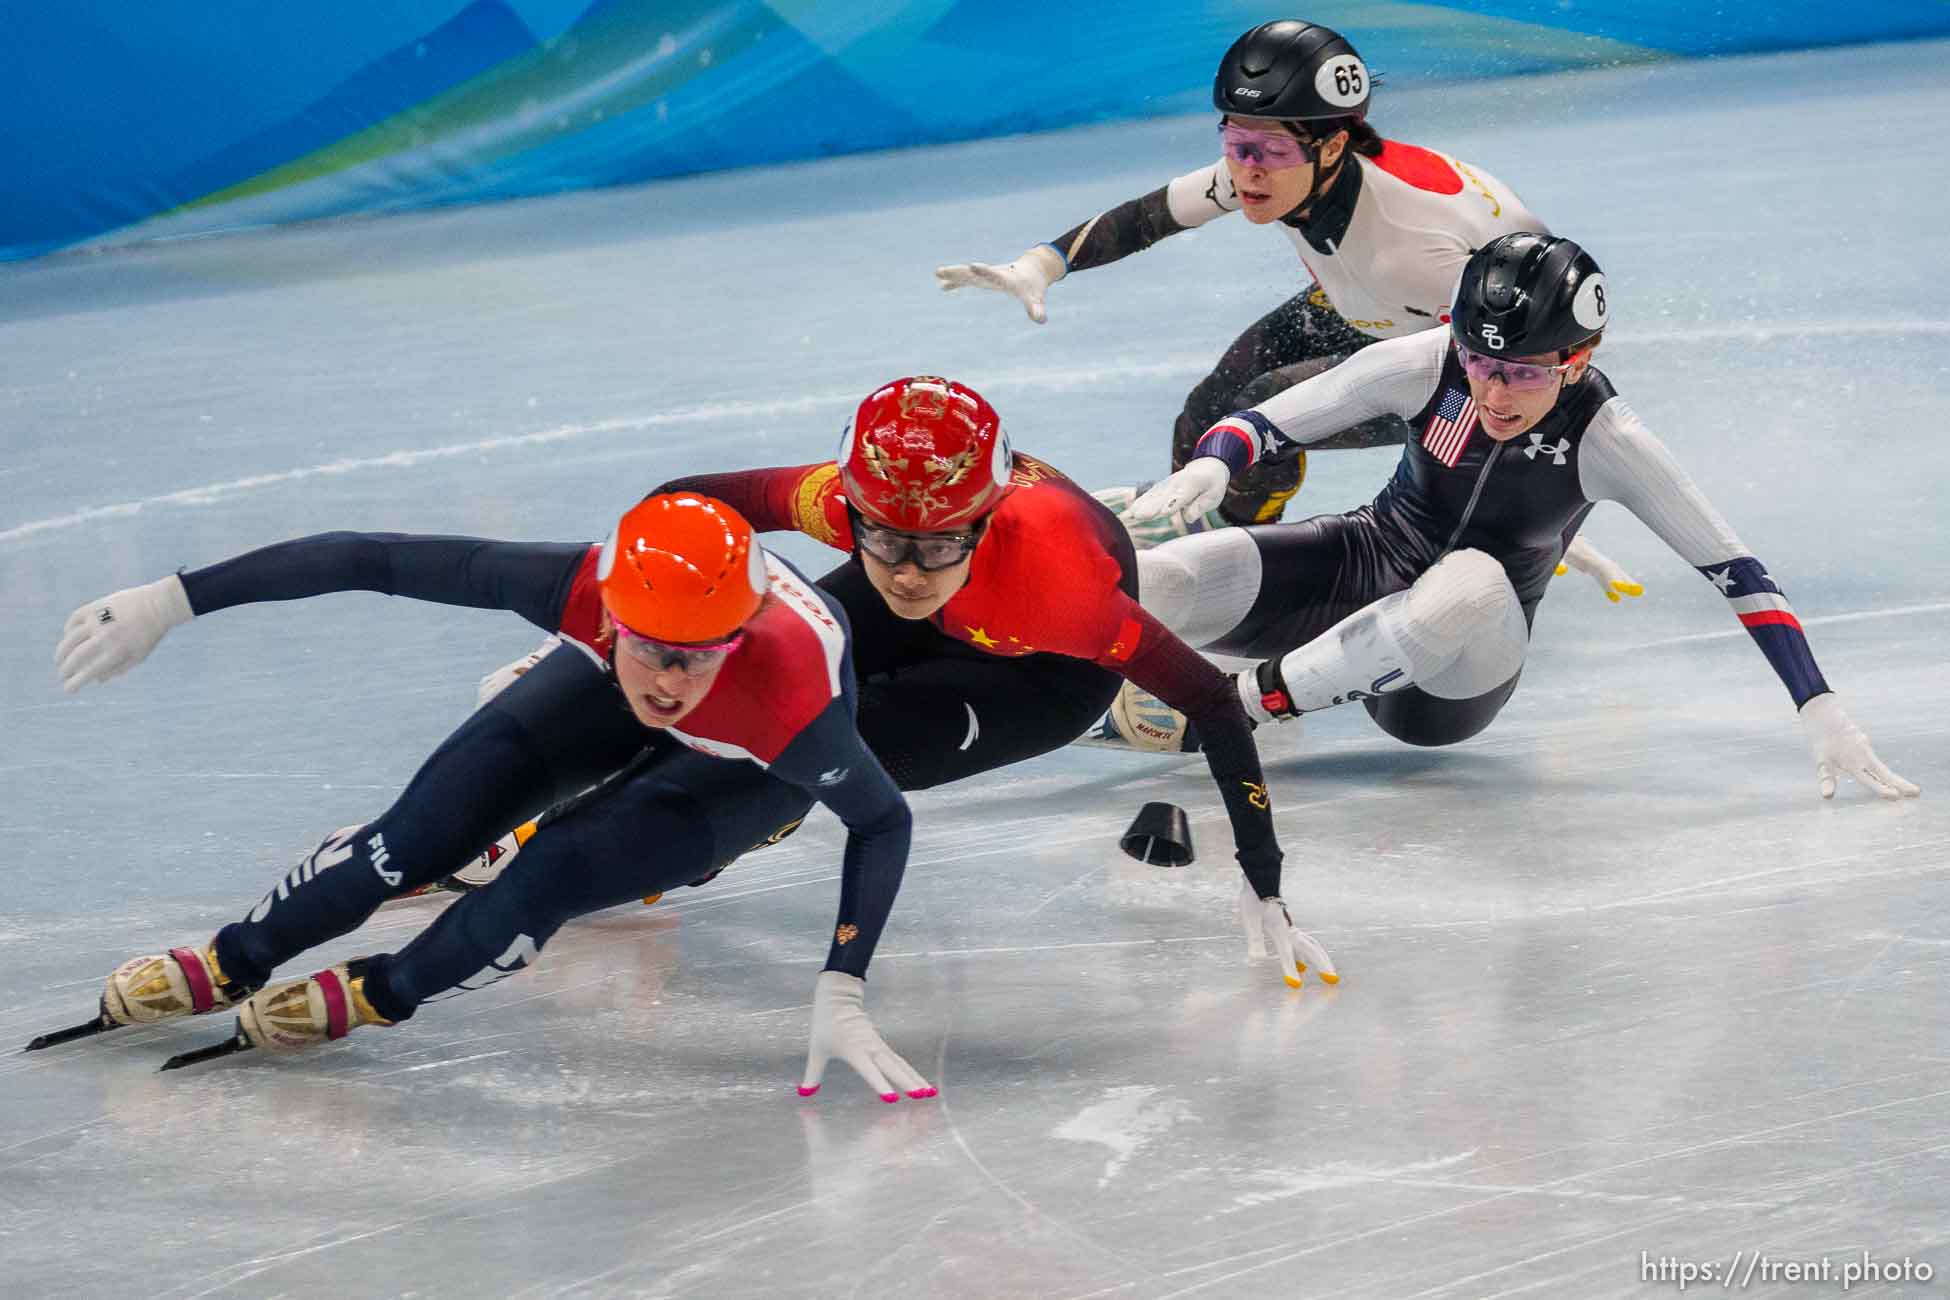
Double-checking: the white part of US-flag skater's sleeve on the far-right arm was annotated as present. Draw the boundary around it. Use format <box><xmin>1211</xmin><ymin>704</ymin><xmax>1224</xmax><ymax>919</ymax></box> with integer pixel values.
<box><xmin>1578</xmin><ymin>398</ymin><xmax>1753</xmax><ymax>567</ymax></box>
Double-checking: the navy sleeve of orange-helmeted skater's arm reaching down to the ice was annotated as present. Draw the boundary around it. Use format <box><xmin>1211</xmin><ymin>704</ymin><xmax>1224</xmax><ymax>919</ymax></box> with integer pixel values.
<box><xmin>770</xmin><ymin>698</ymin><xmax>913</xmax><ymax>978</ymax></box>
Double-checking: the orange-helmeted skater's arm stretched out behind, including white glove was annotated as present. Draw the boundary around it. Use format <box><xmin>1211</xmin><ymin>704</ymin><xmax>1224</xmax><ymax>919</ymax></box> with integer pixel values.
<box><xmin>55</xmin><ymin>532</ymin><xmax>589</xmax><ymax>692</ymax></box>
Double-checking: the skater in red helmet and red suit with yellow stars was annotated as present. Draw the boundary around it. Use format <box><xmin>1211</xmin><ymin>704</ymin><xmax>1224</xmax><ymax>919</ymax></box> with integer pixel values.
<box><xmin>661</xmin><ymin>376</ymin><xmax>1338</xmax><ymax>984</ymax></box>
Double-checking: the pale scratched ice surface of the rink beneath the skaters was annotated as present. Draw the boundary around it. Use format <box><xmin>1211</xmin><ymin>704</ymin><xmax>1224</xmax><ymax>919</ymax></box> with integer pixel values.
<box><xmin>0</xmin><ymin>43</ymin><xmax>1950</xmax><ymax>1300</ymax></box>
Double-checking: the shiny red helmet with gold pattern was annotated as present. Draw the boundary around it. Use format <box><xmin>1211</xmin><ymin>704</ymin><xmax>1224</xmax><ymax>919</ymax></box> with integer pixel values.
<box><xmin>839</xmin><ymin>374</ymin><xmax>1014</xmax><ymax>532</ymax></box>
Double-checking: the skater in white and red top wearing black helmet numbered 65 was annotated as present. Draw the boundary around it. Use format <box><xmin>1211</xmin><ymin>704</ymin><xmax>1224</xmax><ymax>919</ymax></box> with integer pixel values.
<box><xmin>934</xmin><ymin>19</ymin><xmax>1544</xmax><ymax>530</ymax></box>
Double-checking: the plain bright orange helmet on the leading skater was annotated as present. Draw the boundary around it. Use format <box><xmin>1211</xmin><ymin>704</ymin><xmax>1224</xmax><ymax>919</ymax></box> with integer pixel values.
<box><xmin>597</xmin><ymin>491</ymin><xmax>766</xmax><ymax>645</ymax></box>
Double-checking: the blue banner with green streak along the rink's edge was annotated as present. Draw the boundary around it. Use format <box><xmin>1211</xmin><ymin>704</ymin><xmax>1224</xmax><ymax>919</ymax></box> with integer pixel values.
<box><xmin>0</xmin><ymin>0</ymin><xmax>1950</xmax><ymax>259</ymax></box>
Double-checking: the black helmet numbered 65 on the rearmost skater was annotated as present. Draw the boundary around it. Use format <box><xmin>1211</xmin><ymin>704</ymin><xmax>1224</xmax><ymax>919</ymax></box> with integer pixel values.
<box><xmin>1213</xmin><ymin>18</ymin><xmax>1373</xmax><ymax>123</ymax></box>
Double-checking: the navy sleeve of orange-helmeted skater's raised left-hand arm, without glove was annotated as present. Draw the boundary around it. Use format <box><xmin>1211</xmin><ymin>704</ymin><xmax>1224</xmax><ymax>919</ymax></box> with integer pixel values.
<box><xmin>181</xmin><ymin>532</ymin><xmax>589</xmax><ymax>631</ymax></box>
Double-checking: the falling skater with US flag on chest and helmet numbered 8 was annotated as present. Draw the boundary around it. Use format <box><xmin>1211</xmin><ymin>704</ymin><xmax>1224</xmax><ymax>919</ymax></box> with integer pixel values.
<box><xmin>1119</xmin><ymin>234</ymin><xmax>1921</xmax><ymax>799</ymax></box>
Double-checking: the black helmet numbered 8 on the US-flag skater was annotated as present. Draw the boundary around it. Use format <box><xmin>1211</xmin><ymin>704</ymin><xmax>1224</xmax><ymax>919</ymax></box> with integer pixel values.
<box><xmin>1449</xmin><ymin>230</ymin><xmax>1611</xmax><ymax>357</ymax></box>
